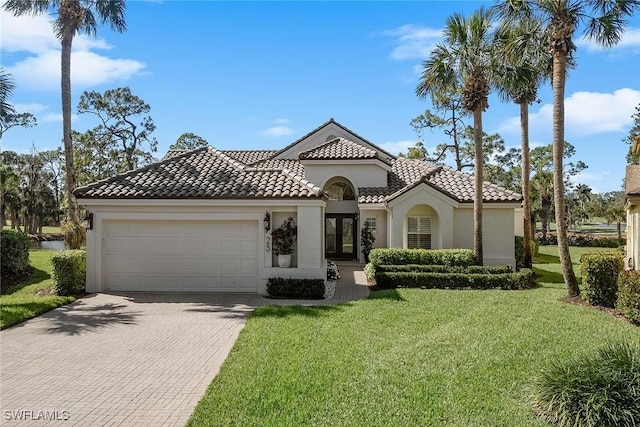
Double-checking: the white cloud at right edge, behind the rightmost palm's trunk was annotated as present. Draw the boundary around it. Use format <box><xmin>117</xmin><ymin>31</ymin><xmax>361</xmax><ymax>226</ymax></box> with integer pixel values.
<box><xmin>498</xmin><ymin>88</ymin><xmax>640</xmax><ymax>137</ymax></box>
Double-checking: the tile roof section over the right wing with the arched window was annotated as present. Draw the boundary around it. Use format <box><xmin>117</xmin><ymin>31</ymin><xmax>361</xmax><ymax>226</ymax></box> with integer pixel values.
<box><xmin>358</xmin><ymin>157</ymin><xmax>522</xmax><ymax>203</ymax></box>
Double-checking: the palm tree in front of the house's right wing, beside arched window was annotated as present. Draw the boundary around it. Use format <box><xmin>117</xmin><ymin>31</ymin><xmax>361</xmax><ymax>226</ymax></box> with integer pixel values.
<box><xmin>416</xmin><ymin>8</ymin><xmax>493</xmax><ymax>264</ymax></box>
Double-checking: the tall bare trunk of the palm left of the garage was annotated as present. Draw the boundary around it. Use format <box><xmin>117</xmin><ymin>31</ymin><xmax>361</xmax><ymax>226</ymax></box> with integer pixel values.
<box><xmin>61</xmin><ymin>27</ymin><xmax>78</xmax><ymax>227</ymax></box>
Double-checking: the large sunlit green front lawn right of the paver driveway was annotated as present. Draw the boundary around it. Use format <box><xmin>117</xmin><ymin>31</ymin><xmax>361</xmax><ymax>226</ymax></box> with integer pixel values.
<box><xmin>188</xmin><ymin>248</ymin><xmax>640</xmax><ymax>426</ymax></box>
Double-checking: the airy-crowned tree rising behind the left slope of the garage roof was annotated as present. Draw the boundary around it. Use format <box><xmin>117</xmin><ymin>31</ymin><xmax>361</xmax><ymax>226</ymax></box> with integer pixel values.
<box><xmin>78</xmin><ymin>87</ymin><xmax>158</xmax><ymax>172</ymax></box>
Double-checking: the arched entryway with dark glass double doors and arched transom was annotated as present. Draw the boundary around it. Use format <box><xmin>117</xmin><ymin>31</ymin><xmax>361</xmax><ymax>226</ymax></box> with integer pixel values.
<box><xmin>323</xmin><ymin>177</ymin><xmax>358</xmax><ymax>259</ymax></box>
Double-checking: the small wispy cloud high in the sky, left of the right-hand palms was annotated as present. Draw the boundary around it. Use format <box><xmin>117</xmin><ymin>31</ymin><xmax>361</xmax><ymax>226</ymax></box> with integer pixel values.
<box><xmin>381</xmin><ymin>24</ymin><xmax>442</xmax><ymax>61</ymax></box>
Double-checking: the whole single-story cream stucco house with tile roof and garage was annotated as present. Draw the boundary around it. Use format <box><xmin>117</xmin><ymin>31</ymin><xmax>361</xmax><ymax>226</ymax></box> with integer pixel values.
<box><xmin>75</xmin><ymin>119</ymin><xmax>521</xmax><ymax>293</ymax></box>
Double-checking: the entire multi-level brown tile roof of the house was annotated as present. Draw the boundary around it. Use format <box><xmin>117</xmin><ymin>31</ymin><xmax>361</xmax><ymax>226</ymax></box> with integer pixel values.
<box><xmin>74</xmin><ymin>119</ymin><xmax>520</xmax><ymax>204</ymax></box>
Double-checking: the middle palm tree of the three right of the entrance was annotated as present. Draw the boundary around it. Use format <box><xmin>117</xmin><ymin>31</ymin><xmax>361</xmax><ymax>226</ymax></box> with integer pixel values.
<box><xmin>494</xmin><ymin>19</ymin><xmax>553</xmax><ymax>268</ymax></box>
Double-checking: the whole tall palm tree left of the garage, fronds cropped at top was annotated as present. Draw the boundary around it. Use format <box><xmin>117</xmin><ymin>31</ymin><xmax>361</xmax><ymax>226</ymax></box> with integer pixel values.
<box><xmin>4</xmin><ymin>0</ymin><xmax>127</xmax><ymax>247</ymax></box>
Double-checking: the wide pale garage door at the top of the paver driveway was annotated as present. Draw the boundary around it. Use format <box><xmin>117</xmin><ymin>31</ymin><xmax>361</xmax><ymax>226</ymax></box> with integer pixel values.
<box><xmin>103</xmin><ymin>221</ymin><xmax>258</xmax><ymax>292</ymax></box>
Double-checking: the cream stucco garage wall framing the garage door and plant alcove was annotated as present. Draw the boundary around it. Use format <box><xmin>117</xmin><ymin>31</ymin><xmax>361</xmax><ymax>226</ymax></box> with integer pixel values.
<box><xmin>78</xmin><ymin>199</ymin><xmax>326</xmax><ymax>293</ymax></box>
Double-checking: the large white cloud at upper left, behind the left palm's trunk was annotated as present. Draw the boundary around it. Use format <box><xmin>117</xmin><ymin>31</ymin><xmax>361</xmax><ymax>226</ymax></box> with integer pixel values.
<box><xmin>0</xmin><ymin>14</ymin><xmax>145</xmax><ymax>90</ymax></box>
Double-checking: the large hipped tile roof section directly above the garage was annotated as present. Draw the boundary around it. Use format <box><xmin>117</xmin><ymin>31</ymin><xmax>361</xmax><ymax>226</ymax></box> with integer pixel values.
<box><xmin>74</xmin><ymin>148</ymin><xmax>322</xmax><ymax>199</ymax></box>
